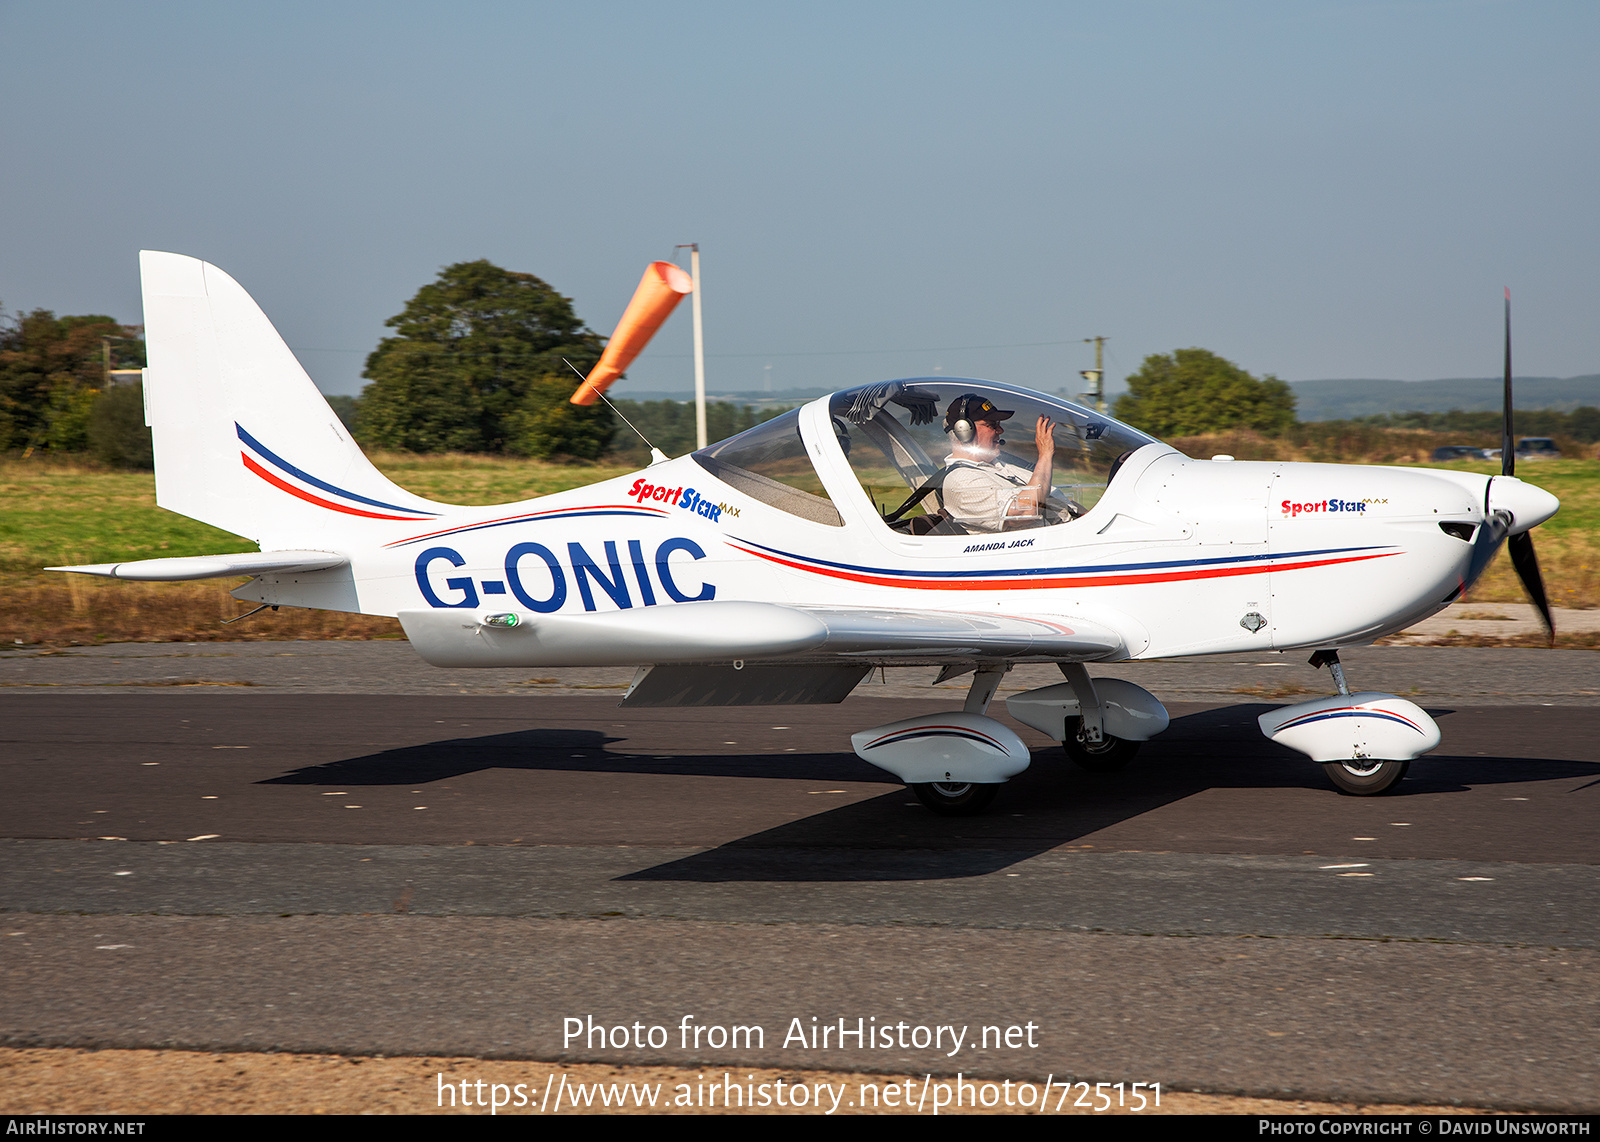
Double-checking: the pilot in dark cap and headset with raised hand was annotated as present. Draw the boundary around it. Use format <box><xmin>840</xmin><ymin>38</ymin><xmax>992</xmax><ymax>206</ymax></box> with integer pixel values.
<box><xmin>942</xmin><ymin>392</ymin><xmax>1070</xmax><ymax>531</ymax></box>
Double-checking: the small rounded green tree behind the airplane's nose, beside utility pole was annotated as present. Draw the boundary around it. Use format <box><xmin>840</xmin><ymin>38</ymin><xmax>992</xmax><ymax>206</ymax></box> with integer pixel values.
<box><xmin>1115</xmin><ymin>349</ymin><xmax>1294</xmax><ymax>437</ymax></box>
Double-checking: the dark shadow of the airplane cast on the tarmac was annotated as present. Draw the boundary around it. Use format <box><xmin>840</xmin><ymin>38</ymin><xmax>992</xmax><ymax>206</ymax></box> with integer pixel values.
<box><xmin>261</xmin><ymin>705</ymin><xmax>1600</xmax><ymax>883</ymax></box>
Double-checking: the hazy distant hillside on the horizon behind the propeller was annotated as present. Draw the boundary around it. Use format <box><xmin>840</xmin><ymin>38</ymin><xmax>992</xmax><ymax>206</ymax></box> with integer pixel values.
<box><xmin>1290</xmin><ymin>373</ymin><xmax>1600</xmax><ymax>421</ymax></box>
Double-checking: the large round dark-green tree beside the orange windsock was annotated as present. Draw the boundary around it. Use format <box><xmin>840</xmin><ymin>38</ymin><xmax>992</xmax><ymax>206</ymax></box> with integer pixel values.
<box><xmin>358</xmin><ymin>261</ymin><xmax>614</xmax><ymax>459</ymax></box>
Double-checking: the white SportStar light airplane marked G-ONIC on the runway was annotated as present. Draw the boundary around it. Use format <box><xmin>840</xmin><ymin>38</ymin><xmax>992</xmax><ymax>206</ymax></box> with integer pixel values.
<box><xmin>51</xmin><ymin>253</ymin><xmax>1560</xmax><ymax>814</ymax></box>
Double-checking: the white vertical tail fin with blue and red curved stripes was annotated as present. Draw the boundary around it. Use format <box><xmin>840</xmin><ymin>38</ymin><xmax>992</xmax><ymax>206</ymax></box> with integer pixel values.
<box><xmin>139</xmin><ymin>251</ymin><xmax>442</xmax><ymax>549</ymax></box>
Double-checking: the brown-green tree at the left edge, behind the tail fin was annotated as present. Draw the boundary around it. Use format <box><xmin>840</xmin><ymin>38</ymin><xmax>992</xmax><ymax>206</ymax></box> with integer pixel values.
<box><xmin>0</xmin><ymin>309</ymin><xmax>144</xmax><ymax>451</ymax></box>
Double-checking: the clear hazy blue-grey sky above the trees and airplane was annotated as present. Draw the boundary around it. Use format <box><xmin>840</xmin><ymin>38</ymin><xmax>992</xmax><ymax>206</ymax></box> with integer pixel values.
<box><xmin>0</xmin><ymin>0</ymin><xmax>1600</xmax><ymax>397</ymax></box>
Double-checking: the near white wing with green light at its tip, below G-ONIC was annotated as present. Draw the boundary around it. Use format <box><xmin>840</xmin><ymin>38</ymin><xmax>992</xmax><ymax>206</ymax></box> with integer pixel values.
<box><xmin>398</xmin><ymin>601</ymin><xmax>1131</xmax><ymax>667</ymax></box>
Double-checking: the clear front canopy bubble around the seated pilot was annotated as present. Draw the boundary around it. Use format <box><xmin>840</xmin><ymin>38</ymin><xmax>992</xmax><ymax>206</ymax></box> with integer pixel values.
<box><xmin>829</xmin><ymin>377</ymin><xmax>1155</xmax><ymax>536</ymax></box>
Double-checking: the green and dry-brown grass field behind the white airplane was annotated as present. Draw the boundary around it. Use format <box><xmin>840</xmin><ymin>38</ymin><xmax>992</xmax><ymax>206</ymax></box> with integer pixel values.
<box><xmin>0</xmin><ymin>453</ymin><xmax>1600</xmax><ymax>645</ymax></box>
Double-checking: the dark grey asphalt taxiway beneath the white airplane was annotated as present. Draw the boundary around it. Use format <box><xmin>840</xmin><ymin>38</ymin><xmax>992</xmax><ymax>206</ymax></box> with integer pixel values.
<box><xmin>0</xmin><ymin>643</ymin><xmax>1600</xmax><ymax>1110</ymax></box>
